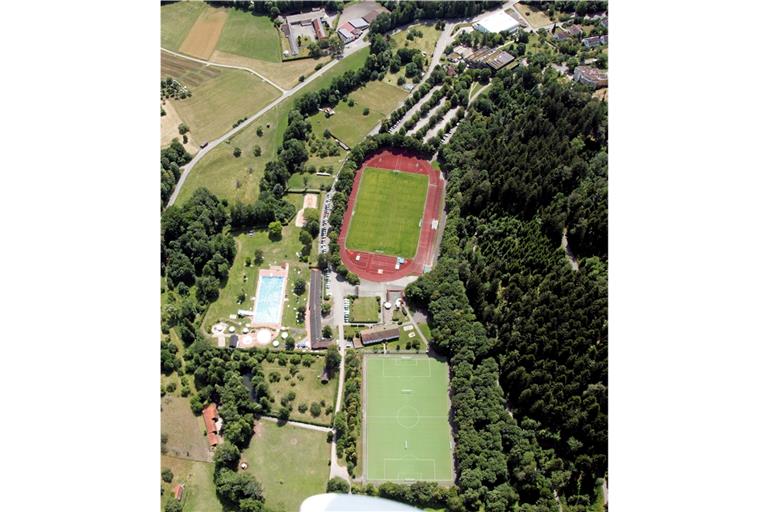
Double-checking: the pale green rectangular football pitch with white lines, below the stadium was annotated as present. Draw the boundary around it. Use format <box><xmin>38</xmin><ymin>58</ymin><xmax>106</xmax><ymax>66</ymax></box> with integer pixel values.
<box><xmin>363</xmin><ymin>355</ymin><xmax>453</xmax><ymax>482</ymax></box>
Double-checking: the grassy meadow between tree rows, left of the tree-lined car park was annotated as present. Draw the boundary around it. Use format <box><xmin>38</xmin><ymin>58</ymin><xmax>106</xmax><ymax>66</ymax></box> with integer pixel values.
<box><xmin>309</xmin><ymin>81</ymin><xmax>408</xmax><ymax>147</ymax></box>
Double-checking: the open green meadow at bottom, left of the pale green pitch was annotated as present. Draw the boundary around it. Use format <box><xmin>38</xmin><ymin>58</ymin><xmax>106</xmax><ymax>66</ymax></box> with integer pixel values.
<box><xmin>243</xmin><ymin>421</ymin><xmax>331</xmax><ymax>512</ymax></box>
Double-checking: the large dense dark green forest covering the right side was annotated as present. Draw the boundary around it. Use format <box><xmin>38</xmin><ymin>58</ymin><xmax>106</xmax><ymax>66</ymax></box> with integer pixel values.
<box><xmin>406</xmin><ymin>66</ymin><xmax>608</xmax><ymax>510</ymax></box>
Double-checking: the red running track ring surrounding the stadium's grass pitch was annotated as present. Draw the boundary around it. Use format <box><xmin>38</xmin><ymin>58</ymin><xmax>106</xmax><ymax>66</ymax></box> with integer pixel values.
<box><xmin>338</xmin><ymin>150</ymin><xmax>445</xmax><ymax>282</ymax></box>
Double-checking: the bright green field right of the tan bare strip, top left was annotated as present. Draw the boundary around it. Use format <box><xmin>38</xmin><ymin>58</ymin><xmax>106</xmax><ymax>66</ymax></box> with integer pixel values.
<box><xmin>216</xmin><ymin>9</ymin><xmax>282</xmax><ymax>62</ymax></box>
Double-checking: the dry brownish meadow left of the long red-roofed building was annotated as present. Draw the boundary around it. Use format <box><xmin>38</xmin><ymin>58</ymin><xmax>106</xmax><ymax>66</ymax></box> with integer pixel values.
<box><xmin>160</xmin><ymin>396</ymin><xmax>211</xmax><ymax>462</ymax></box>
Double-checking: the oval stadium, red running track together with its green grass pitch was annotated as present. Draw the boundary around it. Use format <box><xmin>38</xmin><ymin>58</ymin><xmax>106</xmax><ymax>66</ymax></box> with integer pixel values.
<box><xmin>338</xmin><ymin>150</ymin><xmax>445</xmax><ymax>282</ymax></box>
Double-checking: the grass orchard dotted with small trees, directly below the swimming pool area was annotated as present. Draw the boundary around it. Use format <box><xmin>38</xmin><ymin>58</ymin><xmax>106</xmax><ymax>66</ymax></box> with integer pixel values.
<box><xmin>261</xmin><ymin>355</ymin><xmax>339</xmax><ymax>426</ymax></box>
